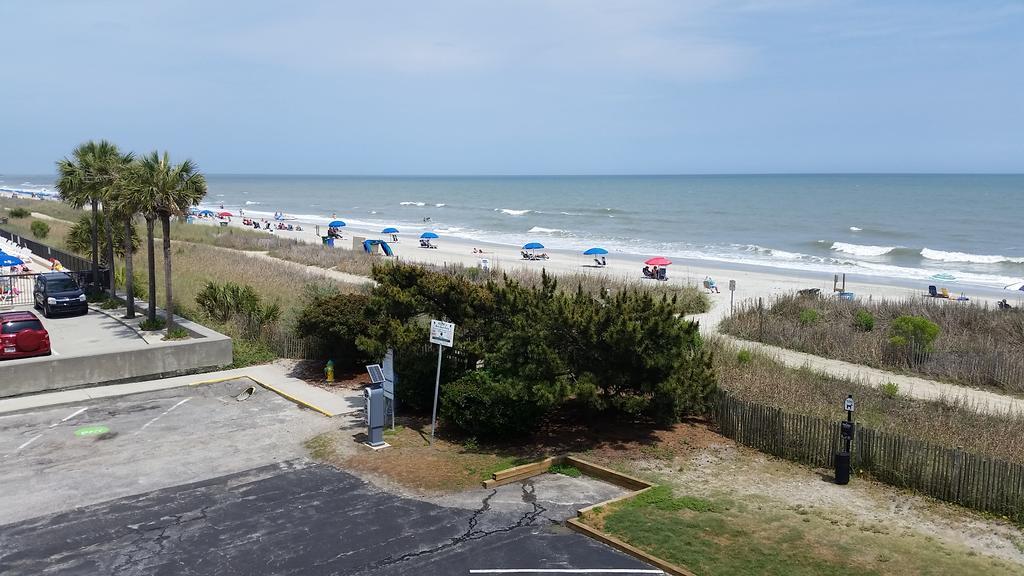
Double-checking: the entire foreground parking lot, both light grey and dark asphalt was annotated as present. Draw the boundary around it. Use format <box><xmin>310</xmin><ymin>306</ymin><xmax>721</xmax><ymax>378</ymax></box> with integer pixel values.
<box><xmin>0</xmin><ymin>380</ymin><xmax>659</xmax><ymax>576</ymax></box>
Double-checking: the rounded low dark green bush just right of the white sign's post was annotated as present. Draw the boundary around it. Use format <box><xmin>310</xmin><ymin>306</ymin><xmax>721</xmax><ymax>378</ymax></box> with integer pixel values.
<box><xmin>440</xmin><ymin>370</ymin><xmax>544</xmax><ymax>439</ymax></box>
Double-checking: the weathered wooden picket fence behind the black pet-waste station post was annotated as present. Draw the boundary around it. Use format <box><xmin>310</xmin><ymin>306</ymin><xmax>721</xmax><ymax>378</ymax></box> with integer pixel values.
<box><xmin>712</xmin><ymin>390</ymin><xmax>1024</xmax><ymax>521</ymax></box>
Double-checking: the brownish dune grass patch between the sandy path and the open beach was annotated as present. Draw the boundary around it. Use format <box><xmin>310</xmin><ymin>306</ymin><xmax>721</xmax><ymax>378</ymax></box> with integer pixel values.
<box><xmin>719</xmin><ymin>295</ymin><xmax>1024</xmax><ymax>394</ymax></box>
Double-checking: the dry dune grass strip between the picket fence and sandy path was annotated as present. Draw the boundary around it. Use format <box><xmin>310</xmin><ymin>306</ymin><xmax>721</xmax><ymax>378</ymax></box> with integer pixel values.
<box><xmin>708</xmin><ymin>338</ymin><xmax>1024</xmax><ymax>463</ymax></box>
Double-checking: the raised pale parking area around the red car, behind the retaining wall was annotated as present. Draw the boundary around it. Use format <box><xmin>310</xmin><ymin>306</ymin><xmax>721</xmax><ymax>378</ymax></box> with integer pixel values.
<box><xmin>0</xmin><ymin>304</ymin><xmax>150</xmax><ymax>358</ymax></box>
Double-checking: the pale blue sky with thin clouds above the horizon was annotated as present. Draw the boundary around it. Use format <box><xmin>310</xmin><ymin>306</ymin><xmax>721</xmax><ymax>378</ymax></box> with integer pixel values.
<box><xmin>0</xmin><ymin>0</ymin><xmax>1024</xmax><ymax>174</ymax></box>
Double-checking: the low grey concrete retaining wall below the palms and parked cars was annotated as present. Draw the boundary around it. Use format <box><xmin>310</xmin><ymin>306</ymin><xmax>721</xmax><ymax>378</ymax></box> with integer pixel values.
<box><xmin>0</xmin><ymin>319</ymin><xmax>231</xmax><ymax>398</ymax></box>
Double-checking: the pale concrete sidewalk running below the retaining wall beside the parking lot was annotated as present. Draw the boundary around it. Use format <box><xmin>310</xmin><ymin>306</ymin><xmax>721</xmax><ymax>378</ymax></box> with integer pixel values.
<box><xmin>0</xmin><ymin>364</ymin><xmax>362</xmax><ymax>417</ymax></box>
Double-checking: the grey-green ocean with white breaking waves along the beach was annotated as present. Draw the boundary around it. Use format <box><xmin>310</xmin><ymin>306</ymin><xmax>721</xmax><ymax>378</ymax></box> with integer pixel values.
<box><xmin>0</xmin><ymin>170</ymin><xmax>1024</xmax><ymax>288</ymax></box>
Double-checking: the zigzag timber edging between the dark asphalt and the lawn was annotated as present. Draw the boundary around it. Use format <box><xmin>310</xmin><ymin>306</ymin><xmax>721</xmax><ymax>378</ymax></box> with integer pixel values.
<box><xmin>483</xmin><ymin>455</ymin><xmax>696</xmax><ymax>576</ymax></box>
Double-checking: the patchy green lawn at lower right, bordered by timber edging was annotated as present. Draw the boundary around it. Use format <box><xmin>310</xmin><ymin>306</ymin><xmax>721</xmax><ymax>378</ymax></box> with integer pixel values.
<box><xmin>584</xmin><ymin>487</ymin><xmax>1021</xmax><ymax>576</ymax></box>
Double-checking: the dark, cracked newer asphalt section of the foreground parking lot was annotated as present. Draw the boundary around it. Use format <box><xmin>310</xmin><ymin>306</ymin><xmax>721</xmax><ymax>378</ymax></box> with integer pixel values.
<box><xmin>0</xmin><ymin>460</ymin><xmax>649</xmax><ymax>576</ymax></box>
